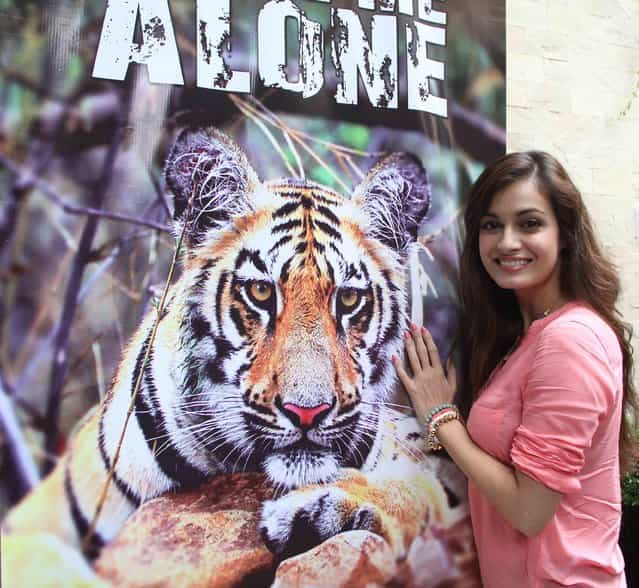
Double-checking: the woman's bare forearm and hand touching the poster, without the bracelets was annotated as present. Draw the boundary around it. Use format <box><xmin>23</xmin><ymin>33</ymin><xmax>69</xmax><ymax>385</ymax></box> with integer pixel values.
<box><xmin>393</xmin><ymin>325</ymin><xmax>561</xmax><ymax>536</ymax></box>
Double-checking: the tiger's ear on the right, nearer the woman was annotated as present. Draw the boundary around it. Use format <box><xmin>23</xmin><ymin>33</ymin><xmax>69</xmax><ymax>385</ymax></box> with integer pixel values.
<box><xmin>353</xmin><ymin>153</ymin><xmax>430</xmax><ymax>253</ymax></box>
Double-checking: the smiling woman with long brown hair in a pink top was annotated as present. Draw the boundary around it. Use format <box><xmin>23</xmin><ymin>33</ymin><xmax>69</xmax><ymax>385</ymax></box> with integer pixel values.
<box><xmin>393</xmin><ymin>152</ymin><xmax>637</xmax><ymax>588</ymax></box>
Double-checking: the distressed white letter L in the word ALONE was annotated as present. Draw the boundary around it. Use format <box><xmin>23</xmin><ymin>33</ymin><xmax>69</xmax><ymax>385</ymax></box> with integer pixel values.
<box><xmin>196</xmin><ymin>0</ymin><xmax>251</xmax><ymax>92</ymax></box>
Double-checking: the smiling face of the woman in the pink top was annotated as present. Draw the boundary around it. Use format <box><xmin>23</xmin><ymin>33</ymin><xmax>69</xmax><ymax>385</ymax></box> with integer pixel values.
<box><xmin>479</xmin><ymin>179</ymin><xmax>561</xmax><ymax>303</ymax></box>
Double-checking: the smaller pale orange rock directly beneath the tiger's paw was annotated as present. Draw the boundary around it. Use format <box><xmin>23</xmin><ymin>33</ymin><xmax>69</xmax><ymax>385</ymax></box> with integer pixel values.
<box><xmin>272</xmin><ymin>531</ymin><xmax>397</xmax><ymax>588</ymax></box>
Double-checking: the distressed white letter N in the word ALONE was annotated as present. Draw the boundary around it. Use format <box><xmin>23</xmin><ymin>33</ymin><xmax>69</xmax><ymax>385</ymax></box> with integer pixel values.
<box><xmin>331</xmin><ymin>8</ymin><xmax>397</xmax><ymax>108</ymax></box>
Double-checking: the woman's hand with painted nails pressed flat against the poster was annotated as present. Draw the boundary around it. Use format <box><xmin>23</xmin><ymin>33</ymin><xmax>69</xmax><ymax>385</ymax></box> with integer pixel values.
<box><xmin>393</xmin><ymin>324</ymin><xmax>456</xmax><ymax>426</ymax></box>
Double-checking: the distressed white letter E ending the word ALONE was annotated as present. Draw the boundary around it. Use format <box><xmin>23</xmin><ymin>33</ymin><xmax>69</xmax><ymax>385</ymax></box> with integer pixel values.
<box><xmin>406</xmin><ymin>22</ymin><xmax>448</xmax><ymax>117</ymax></box>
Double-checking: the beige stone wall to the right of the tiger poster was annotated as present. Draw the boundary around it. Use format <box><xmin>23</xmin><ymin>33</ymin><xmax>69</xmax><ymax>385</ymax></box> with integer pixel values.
<box><xmin>506</xmin><ymin>0</ymin><xmax>639</xmax><ymax>344</ymax></box>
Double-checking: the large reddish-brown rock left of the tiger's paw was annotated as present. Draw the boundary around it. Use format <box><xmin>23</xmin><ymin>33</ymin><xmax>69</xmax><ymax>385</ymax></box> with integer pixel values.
<box><xmin>95</xmin><ymin>474</ymin><xmax>275</xmax><ymax>588</ymax></box>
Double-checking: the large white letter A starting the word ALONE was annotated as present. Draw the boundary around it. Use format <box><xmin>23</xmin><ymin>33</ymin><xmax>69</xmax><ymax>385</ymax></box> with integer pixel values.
<box><xmin>93</xmin><ymin>0</ymin><xmax>184</xmax><ymax>85</ymax></box>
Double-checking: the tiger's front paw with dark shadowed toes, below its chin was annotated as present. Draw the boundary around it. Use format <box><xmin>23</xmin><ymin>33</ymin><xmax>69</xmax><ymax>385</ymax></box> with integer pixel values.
<box><xmin>260</xmin><ymin>487</ymin><xmax>381</xmax><ymax>558</ymax></box>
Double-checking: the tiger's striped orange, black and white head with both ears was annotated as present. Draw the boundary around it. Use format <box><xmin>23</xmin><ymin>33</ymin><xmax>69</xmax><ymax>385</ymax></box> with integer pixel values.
<box><xmin>166</xmin><ymin>129</ymin><xmax>430</xmax><ymax>489</ymax></box>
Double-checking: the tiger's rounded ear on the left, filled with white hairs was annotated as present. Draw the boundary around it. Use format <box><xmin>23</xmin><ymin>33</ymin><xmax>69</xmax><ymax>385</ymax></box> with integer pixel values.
<box><xmin>164</xmin><ymin>128</ymin><xmax>259</xmax><ymax>242</ymax></box>
